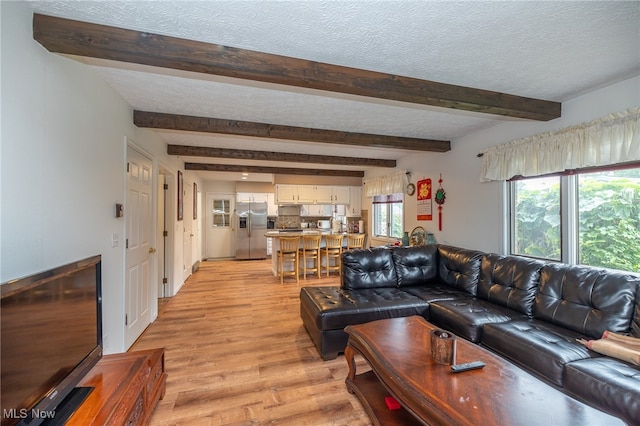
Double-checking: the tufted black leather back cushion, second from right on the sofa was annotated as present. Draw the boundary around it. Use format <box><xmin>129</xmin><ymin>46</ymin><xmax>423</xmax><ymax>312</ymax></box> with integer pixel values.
<box><xmin>477</xmin><ymin>254</ymin><xmax>544</xmax><ymax>316</ymax></box>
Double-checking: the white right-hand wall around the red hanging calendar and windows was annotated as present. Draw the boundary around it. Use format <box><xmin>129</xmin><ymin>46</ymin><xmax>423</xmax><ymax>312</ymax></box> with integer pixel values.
<box><xmin>365</xmin><ymin>77</ymin><xmax>640</xmax><ymax>253</ymax></box>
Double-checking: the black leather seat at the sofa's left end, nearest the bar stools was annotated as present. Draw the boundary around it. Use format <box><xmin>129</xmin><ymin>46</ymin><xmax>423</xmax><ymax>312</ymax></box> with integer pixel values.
<box><xmin>300</xmin><ymin>287</ymin><xmax>429</xmax><ymax>330</ymax></box>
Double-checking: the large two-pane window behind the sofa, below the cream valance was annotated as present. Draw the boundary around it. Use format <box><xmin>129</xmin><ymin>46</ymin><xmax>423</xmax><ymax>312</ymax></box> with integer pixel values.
<box><xmin>509</xmin><ymin>165</ymin><xmax>640</xmax><ymax>272</ymax></box>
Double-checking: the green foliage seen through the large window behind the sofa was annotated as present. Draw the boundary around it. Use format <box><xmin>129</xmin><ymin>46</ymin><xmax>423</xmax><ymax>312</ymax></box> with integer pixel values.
<box><xmin>513</xmin><ymin>169</ymin><xmax>640</xmax><ymax>272</ymax></box>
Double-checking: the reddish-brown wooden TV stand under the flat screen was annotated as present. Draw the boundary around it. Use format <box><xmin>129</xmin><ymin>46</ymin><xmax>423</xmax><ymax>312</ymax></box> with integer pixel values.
<box><xmin>66</xmin><ymin>349</ymin><xmax>167</xmax><ymax>426</ymax></box>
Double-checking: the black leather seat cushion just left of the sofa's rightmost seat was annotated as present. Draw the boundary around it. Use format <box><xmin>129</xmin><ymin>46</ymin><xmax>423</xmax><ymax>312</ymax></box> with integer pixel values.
<box><xmin>481</xmin><ymin>319</ymin><xmax>600</xmax><ymax>386</ymax></box>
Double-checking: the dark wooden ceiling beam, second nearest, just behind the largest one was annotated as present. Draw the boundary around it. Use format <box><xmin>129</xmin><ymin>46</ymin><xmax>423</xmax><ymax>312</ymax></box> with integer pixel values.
<box><xmin>133</xmin><ymin>111</ymin><xmax>451</xmax><ymax>152</ymax></box>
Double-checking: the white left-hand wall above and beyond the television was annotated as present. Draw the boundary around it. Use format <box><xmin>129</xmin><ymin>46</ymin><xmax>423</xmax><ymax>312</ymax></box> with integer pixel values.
<box><xmin>0</xmin><ymin>1</ymin><xmax>200</xmax><ymax>353</ymax></box>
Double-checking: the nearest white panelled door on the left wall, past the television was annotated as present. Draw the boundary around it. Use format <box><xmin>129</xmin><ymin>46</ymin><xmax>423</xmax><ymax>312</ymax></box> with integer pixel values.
<box><xmin>124</xmin><ymin>147</ymin><xmax>155</xmax><ymax>348</ymax></box>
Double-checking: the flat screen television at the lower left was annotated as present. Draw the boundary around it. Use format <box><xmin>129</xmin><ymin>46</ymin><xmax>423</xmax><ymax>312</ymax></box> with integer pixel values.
<box><xmin>0</xmin><ymin>255</ymin><xmax>102</xmax><ymax>426</ymax></box>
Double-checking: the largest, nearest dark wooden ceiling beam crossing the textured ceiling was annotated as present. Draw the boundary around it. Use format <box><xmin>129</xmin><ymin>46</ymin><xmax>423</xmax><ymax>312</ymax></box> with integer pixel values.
<box><xmin>33</xmin><ymin>13</ymin><xmax>561</xmax><ymax>121</ymax></box>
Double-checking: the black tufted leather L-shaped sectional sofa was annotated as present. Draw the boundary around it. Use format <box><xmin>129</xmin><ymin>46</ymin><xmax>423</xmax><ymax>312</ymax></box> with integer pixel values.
<box><xmin>300</xmin><ymin>245</ymin><xmax>640</xmax><ymax>424</ymax></box>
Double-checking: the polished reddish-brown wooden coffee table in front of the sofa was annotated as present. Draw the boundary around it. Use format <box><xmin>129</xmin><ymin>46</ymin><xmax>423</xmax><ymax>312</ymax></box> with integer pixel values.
<box><xmin>344</xmin><ymin>316</ymin><xmax>624</xmax><ymax>426</ymax></box>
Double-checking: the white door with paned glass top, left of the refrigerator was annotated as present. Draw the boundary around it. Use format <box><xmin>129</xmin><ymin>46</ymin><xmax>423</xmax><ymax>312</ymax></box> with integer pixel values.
<box><xmin>205</xmin><ymin>192</ymin><xmax>236</xmax><ymax>259</ymax></box>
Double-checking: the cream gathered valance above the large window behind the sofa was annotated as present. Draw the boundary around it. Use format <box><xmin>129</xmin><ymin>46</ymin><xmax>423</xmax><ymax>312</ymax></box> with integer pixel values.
<box><xmin>480</xmin><ymin>108</ymin><xmax>640</xmax><ymax>181</ymax></box>
